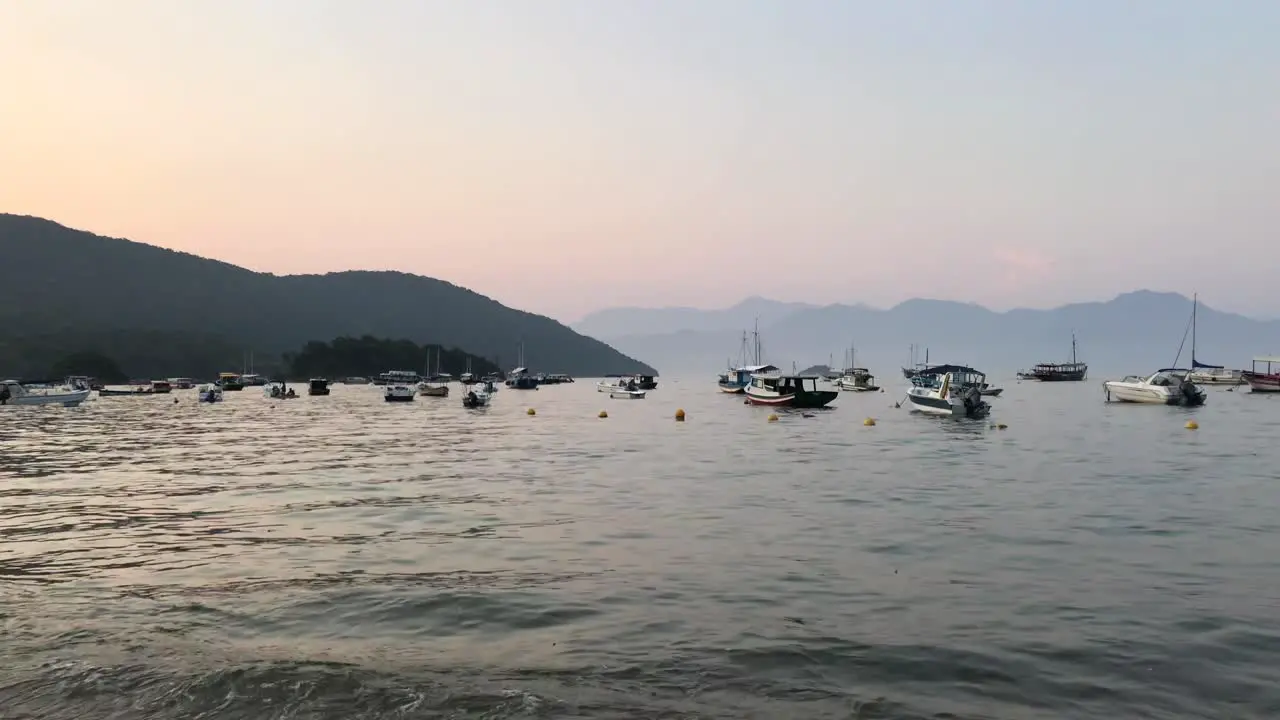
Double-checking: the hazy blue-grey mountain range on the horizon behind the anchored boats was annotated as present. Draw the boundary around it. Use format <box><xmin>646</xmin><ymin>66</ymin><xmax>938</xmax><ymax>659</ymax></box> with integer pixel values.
<box><xmin>584</xmin><ymin>290</ymin><xmax>1280</xmax><ymax>379</ymax></box>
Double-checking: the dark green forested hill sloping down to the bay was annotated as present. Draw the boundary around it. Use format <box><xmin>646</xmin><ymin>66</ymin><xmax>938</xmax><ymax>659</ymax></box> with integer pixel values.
<box><xmin>0</xmin><ymin>214</ymin><xmax>653</xmax><ymax>375</ymax></box>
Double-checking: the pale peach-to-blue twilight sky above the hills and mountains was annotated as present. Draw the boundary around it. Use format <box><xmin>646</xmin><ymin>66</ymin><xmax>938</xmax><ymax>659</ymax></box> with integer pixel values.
<box><xmin>0</xmin><ymin>0</ymin><xmax>1280</xmax><ymax>320</ymax></box>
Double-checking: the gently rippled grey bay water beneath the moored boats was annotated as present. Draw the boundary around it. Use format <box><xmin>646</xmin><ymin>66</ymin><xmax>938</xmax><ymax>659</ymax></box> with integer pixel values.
<box><xmin>0</xmin><ymin>378</ymin><xmax>1280</xmax><ymax>720</ymax></box>
